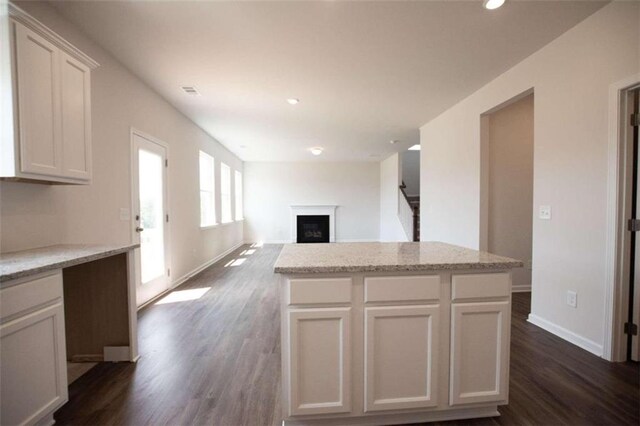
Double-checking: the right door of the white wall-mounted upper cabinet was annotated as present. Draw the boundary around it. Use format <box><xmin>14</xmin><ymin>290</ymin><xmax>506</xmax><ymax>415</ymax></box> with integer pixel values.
<box><xmin>60</xmin><ymin>52</ymin><xmax>91</xmax><ymax>180</ymax></box>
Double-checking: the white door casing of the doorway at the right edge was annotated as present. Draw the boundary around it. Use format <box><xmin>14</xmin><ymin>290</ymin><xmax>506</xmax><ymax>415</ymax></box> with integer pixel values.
<box><xmin>602</xmin><ymin>73</ymin><xmax>640</xmax><ymax>362</ymax></box>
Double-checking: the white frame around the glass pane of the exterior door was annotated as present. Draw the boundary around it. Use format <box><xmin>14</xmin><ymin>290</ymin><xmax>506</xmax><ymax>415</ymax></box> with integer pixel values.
<box><xmin>129</xmin><ymin>127</ymin><xmax>173</xmax><ymax>309</ymax></box>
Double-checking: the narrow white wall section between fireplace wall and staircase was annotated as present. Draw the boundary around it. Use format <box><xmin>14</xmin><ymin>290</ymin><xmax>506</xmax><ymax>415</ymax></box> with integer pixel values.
<box><xmin>380</xmin><ymin>154</ymin><xmax>409</xmax><ymax>241</ymax></box>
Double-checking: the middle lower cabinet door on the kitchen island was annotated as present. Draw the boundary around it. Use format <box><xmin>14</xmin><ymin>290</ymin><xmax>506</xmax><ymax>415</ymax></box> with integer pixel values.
<box><xmin>365</xmin><ymin>305</ymin><xmax>439</xmax><ymax>412</ymax></box>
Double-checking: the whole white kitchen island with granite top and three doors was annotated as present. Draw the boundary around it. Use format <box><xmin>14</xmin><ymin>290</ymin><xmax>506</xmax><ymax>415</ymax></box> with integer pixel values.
<box><xmin>275</xmin><ymin>242</ymin><xmax>522</xmax><ymax>425</ymax></box>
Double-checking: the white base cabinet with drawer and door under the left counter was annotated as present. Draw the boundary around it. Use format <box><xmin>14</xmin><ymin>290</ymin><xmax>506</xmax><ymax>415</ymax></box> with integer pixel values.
<box><xmin>0</xmin><ymin>274</ymin><xmax>68</xmax><ymax>425</ymax></box>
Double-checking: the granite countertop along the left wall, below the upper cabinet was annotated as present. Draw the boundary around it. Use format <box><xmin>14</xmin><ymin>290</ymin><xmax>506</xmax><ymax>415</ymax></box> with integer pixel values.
<box><xmin>0</xmin><ymin>244</ymin><xmax>140</xmax><ymax>282</ymax></box>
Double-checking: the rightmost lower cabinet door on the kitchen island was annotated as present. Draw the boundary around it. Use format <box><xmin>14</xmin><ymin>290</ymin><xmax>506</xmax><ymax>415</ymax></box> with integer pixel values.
<box><xmin>450</xmin><ymin>301</ymin><xmax>510</xmax><ymax>405</ymax></box>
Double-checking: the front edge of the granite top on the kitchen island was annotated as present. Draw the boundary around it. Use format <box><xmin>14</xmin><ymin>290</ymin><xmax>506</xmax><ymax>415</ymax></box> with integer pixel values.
<box><xmin>274</xmin><ymin>262</ymin><xmax>524</xmax><ymax>275</ymax></box>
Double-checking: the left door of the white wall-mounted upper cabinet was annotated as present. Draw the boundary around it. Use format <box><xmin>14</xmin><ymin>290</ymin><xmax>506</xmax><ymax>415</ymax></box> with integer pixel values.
<box><xmin>15</xmin><ymin>25</ymin><xmax>62</xmax><ymax>176</ymax></box>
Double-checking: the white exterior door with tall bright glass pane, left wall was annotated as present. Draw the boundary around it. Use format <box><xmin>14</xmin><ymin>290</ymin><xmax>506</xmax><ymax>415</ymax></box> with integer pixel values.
<box><xmin>132</xmin><ymin>133</ymin><xmax>170</xmax><ymax>306</ymax></box>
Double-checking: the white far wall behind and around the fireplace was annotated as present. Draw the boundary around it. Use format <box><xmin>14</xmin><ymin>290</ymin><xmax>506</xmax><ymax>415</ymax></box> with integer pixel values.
<box><xmin>244</xmin><ymin>162</ymin><xmax>380</xmax><ymax>242</ymax></box>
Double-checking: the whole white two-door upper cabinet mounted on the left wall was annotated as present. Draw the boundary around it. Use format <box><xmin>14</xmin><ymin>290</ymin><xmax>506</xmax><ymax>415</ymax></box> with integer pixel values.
<box><xmin>0</xmin><ymin>4</ymin><xmax>98</xmax><ymax>184</ymax></box>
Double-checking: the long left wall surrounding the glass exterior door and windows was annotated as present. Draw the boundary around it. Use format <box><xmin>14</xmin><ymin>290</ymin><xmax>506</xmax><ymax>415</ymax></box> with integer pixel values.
<box><xmin>0</xmin><ymin>2</ymin><xmax>243</xmax><ymax>280</ymax></box>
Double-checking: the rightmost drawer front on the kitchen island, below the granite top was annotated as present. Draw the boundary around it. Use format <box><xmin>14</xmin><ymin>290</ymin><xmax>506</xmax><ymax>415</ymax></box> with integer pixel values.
<box><xmin>451</xmin><ymin>272</ymin><xmax>511</xmax><ymax>300</ymax></box>
